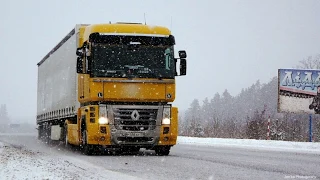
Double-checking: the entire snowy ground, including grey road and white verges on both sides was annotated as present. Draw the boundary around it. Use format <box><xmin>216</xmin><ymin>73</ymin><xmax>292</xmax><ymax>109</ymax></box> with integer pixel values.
<box><xmin>0</xmin><ymin>134</ymin><xmax>320</xmax><ymax>180</ymax></box>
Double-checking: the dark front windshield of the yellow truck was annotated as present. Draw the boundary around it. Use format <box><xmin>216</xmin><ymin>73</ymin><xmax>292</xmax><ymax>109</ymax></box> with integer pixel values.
<box><xmin>92</xmin><ymin>44</ymin><xmax>175</xmax><ymax>78</ymax></box>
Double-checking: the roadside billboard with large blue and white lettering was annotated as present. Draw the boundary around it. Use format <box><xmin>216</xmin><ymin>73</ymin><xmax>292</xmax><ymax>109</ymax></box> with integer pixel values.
<box><xmin>278</xmin><ymin>69</ymin><xmax>320</xmax><ymax>114</ymax></box>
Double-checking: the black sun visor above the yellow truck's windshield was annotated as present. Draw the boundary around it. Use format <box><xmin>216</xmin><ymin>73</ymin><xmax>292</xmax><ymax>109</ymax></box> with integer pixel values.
<box><xmin>89</xmin><ymin>33</ymin><xmax>175</xmax><ymax>46</ymax></box>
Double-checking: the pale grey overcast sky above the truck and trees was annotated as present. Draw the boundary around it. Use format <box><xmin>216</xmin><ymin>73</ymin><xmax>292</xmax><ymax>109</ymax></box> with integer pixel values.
<box><xmin>0</xmin><ymin>0</ymin><xmax>320</xmax><ymax>122</ymax></box>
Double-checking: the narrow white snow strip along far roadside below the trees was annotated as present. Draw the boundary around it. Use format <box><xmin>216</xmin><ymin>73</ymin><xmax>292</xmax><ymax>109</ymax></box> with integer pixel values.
<box><xmin>177</xmin><ymin>136</ymin><xmax>320</xmax><ymax>154</ymax></box>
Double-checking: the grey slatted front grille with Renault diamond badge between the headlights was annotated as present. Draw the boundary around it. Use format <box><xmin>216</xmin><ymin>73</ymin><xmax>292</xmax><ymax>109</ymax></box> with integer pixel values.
<box><xmin>113</xmin><ymin>108</ymin><xmax>158</xmax><ymax>131</ymax></box>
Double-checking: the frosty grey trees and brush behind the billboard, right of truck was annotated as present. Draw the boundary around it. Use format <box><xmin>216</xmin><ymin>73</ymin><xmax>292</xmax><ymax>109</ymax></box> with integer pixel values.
<box><xmin>179</xmin><ymin>54</ymin><xmax>320</xmax><ymax>141</ymax></box>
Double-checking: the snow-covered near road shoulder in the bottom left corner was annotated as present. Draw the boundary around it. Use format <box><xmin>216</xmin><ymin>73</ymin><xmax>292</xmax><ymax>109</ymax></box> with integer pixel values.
<box><xmin>0</xmin><ymin>142</ymin><xmax>141</xmax><ymax>180</ymax></box>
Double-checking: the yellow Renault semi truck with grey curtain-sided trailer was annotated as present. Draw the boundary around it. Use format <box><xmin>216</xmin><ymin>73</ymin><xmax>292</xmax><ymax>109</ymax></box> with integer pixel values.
<box><xmin>37</xmin><ymin>23</ymin><xmax>187</xmax><ymax>155</ymax></box>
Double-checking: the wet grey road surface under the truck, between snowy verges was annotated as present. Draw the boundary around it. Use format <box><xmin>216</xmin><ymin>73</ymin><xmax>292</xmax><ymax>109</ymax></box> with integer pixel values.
<box><xmin>0</xmin><ymin>134</ymin><xmax>320</xmax><ymax>180</ymax></box>
